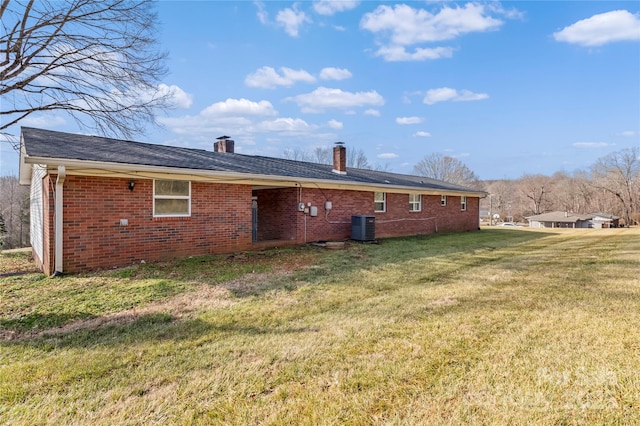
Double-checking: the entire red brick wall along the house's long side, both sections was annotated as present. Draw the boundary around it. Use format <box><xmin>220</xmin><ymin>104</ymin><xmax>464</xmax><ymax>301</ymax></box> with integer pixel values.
<box><xmin>43</xmin><ymin>175</ymin><xmax>479</xmax><ymax>274</ymax></box>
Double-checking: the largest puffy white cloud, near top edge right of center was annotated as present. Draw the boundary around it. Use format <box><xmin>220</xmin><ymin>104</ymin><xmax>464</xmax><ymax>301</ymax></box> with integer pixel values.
<box><xmin>360</xmin><ymin>3</ymin><xmax>504</xmax><ymax>61</ymax></box>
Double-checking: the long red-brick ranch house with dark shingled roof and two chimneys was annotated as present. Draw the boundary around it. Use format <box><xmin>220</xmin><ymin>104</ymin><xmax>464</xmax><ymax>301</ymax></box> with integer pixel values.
<box><xmin>20</xmin><ymin>127</ymin><xmax>486</xmax><ymax>274</ymax></box>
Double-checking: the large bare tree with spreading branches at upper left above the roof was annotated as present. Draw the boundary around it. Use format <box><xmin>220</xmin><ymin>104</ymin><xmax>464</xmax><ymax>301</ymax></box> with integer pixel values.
<box><xmin>0</xmin><ymin>0</ymin><xmax>171</xmax><ymax>137</ymax></box>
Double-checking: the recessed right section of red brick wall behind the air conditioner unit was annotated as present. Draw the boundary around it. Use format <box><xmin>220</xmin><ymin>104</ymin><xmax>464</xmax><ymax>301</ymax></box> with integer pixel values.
<box><xmin>254</xmin><ymin>188</ymin><xmax>479</xmax><ymax>242</ymax></box>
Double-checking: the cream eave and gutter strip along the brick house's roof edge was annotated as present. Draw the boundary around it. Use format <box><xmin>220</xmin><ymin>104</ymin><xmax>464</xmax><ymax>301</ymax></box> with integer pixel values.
<box><xmin>20</xmin><ymin>155</ymin><xmax>486</xmax><ymax>197</ymax></box>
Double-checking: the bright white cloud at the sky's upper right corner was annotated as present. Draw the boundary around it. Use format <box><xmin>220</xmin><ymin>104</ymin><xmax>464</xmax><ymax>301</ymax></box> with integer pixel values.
<box><xmin>553</xmin><ymin>10</ymin><xmax>640</xmax><ymax>46</ymax></box>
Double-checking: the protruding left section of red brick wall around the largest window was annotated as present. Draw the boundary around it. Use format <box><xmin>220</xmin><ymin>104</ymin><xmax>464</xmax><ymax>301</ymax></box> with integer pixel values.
<box><xmin>49</xmin><ymin>176</ymin><xmax>251</xmax><ymax>272</ymax></box>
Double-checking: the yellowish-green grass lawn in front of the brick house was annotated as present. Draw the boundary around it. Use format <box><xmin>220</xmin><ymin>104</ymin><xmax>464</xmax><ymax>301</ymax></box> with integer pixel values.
<box><xmin>0</xmin><ymin>228</ymin><xmax>640</xmax><ymax>425</ymax></box>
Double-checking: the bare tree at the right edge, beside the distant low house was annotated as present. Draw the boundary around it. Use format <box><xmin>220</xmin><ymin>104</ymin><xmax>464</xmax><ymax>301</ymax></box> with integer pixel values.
<box><xmin>591</xmin><ymin>147</ymin><xmax>640</xmax><ymax>225</ymax></box>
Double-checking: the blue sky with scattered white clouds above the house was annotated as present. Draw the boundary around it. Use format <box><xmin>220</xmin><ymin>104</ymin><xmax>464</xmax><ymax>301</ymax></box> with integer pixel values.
<box><xmin>0</xmin><ymin>0</ymin><xmax>640</xmax><ymax>179</ymax></box>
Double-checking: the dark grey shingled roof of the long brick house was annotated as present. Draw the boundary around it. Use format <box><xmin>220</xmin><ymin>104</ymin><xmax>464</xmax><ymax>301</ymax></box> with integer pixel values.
<box><xmin>20</xmin><ymin>127</ymin><xmax>485</xmax><ymax>196</ymax></box>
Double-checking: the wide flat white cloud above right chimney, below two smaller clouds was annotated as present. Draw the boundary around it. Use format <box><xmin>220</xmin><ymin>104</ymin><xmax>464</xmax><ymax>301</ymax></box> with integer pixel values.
<box><xmin>285</xmin><ymin>87</ymin><xmax>384</xmax><ymax>113</ymax></box>
